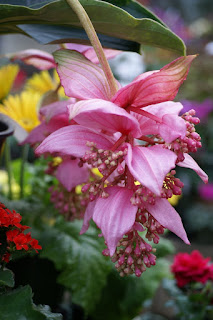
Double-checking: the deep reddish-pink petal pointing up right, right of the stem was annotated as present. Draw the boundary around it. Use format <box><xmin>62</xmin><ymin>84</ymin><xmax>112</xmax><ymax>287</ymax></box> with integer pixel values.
<box><xmin>112</xmin><ymin>55</ymin><xmax>196</xmax><ymax>108</ymax></box>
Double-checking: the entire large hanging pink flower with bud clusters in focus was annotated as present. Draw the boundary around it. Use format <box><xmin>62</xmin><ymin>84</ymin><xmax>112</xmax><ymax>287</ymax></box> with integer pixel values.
<box><xmin>32</xmin><ymin>50</ymin><xmax>208</xmax><ymax>276</ymax></box>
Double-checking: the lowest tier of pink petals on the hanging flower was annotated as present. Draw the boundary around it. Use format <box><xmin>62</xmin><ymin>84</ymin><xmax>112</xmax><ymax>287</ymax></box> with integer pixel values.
<box><xmin>81</xmin><ymin>186</ymin><xmax>189</xmax><ymax>256</ymax></box>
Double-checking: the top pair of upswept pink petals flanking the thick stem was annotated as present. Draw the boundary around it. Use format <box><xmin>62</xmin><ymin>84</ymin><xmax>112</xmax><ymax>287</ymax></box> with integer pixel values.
<box><xmin>53</xmin><ymin>49</ymin><xmax>196</xmax><ymax>102</ymax></box>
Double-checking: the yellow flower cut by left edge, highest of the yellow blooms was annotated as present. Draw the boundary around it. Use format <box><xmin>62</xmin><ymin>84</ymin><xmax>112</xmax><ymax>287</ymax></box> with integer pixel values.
<box><xmin>0</xmin><ymin>64</ymin><xmax>19</xmax><ymax>100</ymax></box>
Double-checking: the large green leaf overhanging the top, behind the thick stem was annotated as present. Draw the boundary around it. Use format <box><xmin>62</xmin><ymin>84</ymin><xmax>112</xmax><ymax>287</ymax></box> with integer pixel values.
<box><xmin>0</xmin><ymin>0</ymin><xmax>185</xmax><ymax>54</ymax></box>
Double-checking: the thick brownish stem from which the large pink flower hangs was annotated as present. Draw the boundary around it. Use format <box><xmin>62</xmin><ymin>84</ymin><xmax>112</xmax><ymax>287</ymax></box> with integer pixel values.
<box><xmin>66</xmin><ymin>0</ymin><xmax>118</xmax><ymax>96</ymax></box>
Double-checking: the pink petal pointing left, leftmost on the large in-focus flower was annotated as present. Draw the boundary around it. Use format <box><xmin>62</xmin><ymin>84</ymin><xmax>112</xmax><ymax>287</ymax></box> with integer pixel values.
<box><xmin>36</xmin><ymin>125</ymin><xmax>113</xmax><ymax>157</ymax></box>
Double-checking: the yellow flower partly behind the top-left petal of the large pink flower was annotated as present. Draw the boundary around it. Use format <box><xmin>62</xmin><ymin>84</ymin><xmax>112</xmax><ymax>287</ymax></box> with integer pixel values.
<box><xmin>25</xmin><ymin>70</ymin><xmax>65</xmax><ymax>97</ymax></box>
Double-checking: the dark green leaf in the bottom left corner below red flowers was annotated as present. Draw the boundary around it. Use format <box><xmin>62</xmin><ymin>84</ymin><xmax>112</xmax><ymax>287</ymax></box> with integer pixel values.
<box><xmin>0</xmin><ymin>286</ymin><xmax>62</xmax><ymax>320</ymax></box>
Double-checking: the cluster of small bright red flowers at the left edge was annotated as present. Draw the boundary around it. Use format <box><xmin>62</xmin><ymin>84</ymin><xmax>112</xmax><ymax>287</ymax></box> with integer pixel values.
<box><xmin>0</xmin><ymin>202</ymin><xmax>42</xmax><ymax>263</ymax></box>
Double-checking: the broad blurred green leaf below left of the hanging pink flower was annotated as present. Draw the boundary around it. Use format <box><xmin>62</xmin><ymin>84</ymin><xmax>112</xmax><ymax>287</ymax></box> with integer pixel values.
<box><xmin>41</xmin><ymin>221</ymin><xmax>111</xmax><ymax>312</ymax></box>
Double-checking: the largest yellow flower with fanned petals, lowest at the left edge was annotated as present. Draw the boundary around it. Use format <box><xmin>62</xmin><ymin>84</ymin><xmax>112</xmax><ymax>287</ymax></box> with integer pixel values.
<box><xmin>0</xmin><ymin>91</ymin><xmax>41</xmax><ymax>132</ymax></box>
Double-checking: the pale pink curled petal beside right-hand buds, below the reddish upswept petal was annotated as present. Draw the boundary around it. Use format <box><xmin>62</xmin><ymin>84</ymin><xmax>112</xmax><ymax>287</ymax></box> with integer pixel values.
<box><xmin>137</xmin><ymin>101</ymin><xmax>186</xmax><ymax>143</ymax></box>
